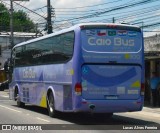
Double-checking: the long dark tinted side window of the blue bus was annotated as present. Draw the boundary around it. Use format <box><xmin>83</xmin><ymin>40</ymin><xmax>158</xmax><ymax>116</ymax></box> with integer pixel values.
<box><xmin>15</xmin><ymin>32</ymin><xmax>74</xmax><ymax>66</ymax></box>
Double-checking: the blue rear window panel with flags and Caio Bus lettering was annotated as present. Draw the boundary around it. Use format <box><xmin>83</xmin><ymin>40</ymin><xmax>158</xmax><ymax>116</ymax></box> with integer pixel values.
<box><xmin>81</xmin><ymin>29</ymin><xmax>142</xmax><ymax>52</ymax></box>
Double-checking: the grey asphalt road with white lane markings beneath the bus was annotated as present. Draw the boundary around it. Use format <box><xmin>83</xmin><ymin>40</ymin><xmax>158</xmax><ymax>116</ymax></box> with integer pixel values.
<box><xmin>0</xmin><ymin>91</ymin><xmax>160</xmax><ymax>133</ymax></box>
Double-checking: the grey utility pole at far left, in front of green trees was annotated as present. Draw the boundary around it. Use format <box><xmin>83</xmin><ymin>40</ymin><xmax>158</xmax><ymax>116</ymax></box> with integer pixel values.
<box><xmin>10</xmin><ymin>0</ymin><xmax>14</xmax><ymax>48</ymax></box>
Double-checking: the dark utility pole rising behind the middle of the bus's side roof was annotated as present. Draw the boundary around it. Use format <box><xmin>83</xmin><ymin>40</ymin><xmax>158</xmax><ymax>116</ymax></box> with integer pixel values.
<box><xmin>47</xmin><ymin>0</ymin><xmax>53</xmax><ymax>34</ymax></box>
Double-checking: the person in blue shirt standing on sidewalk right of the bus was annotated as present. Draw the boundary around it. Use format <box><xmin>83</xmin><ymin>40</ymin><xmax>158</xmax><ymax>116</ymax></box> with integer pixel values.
<box><xmin>150</xmin><ymin>72</ymin><xmax>160</xmax><ymax>107</ymax></box>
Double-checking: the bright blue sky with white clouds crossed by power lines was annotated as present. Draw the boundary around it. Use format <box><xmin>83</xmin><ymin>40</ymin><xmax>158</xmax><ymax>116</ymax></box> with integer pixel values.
<box><xmin>2</xmin><ymin>0</ymin><xmax>160</xmax><ymax>36</ymax></box>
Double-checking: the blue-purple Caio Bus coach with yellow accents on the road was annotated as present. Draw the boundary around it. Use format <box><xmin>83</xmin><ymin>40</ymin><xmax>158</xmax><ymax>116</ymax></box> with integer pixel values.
<box><xmin>9</xmin><ymin>23</ymin><xmax>144</xmax><ymax>117</ymax></box>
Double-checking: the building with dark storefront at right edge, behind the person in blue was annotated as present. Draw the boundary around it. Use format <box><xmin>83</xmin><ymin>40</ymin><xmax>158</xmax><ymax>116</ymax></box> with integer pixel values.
<box><xmin>144</xmin><ymin>35</ymin><xmax>160</xmax><ymax>105</ymax></box>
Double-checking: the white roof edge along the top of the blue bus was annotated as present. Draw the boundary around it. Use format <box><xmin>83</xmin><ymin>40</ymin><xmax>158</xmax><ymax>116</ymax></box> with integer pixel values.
<box><xmin>13</xmin><ymin>23</ymin><xmax>139</xmax><ymax>48</ymax></box>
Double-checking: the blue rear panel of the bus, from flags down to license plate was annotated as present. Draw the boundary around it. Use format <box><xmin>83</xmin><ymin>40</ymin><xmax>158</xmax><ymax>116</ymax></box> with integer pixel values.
<box><xmin>81</xmin><ymin>25</ymin><xmax>143</xmax><ymax>100</ymax></box>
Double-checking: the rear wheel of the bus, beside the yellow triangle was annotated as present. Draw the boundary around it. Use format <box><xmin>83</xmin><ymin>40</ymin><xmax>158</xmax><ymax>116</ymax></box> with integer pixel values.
<box><xmin>48</xmin><ymin>93</ymin><xmax>57</xmax><ymax>117</ymax></box>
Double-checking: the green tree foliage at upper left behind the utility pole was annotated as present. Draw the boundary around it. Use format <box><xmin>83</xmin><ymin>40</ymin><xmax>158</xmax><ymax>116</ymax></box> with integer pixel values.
<box><xmin>0</xmin><ymin>3</ymin><xmax>36</xmax><ymax>32</ymax></box>
